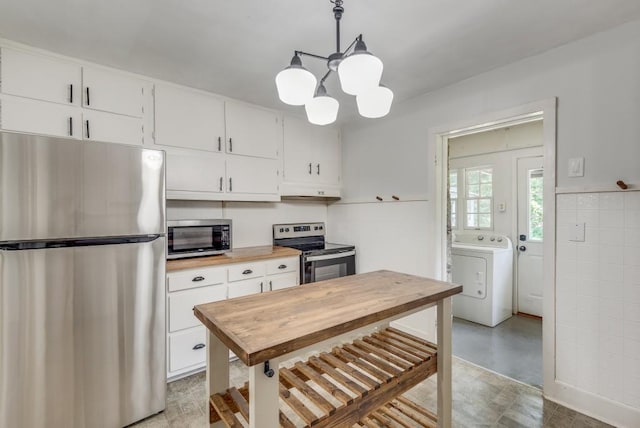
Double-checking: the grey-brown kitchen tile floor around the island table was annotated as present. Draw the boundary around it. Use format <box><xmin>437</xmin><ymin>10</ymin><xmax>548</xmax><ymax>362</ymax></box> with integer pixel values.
<box><xmin>129</xmin><ymin>357</ymin><xmax>610</xmax><ymax>428</ymax></box>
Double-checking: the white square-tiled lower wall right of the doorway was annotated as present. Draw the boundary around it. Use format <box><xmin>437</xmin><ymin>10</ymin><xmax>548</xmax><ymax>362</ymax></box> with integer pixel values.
<box><xmin>556</xmin><ymin>191</ymin><xmax>640</xmax><ymax>407</ymax></box>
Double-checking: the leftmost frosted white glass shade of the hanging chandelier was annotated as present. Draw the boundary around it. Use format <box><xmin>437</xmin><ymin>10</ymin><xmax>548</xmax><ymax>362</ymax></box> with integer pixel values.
<box><xmin>276</xmin><ymin>55</ymin><xmax>318</xmax><ymax>106</ymax></box>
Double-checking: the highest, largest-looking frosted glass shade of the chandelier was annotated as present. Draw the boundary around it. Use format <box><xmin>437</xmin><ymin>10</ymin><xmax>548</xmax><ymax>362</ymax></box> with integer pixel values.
<box><xmin>338</xmin><ymin>40</ymin><xmax>383</xmax><ymax>95</ymax></box>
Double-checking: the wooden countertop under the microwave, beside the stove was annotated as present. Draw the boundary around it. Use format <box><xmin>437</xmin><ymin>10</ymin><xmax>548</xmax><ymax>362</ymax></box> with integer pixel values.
<box><xmin>167</xmin><ymin>245</ymin><xmax>301</xmax><ymax>272</ymax></box>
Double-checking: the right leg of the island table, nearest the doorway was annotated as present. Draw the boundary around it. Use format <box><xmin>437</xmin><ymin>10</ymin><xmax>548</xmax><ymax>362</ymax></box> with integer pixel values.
<box><xmin>437</xmin><ymin>297</ymin><xmax>452</xmax><ymax>428</ymax></box>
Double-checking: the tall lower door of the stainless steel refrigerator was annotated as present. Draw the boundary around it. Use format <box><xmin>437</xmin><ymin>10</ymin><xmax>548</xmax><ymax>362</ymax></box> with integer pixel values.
<box><xmin>0</xmin><ymin>238</ymin><xmax>166</xmax><ymax>428</ymax></box>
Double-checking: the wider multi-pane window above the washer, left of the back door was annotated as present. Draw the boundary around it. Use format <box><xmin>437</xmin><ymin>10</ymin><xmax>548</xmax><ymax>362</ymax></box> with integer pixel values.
<box><xmin>464</xmin><ymin>167</ymin><xmax>493</xmax><ymax>229</ymax></box>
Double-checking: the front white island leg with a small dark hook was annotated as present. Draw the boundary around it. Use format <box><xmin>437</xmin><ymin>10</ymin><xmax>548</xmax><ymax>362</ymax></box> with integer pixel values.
<box><xmin>249</xmin><ymin>359</ymin><xmax>280</xmax><ymax>428</ymax></box>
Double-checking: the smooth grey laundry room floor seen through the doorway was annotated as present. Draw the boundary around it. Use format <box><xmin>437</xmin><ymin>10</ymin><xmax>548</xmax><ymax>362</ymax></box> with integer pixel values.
<box><xmin>452</xmin><ymin>315</ymin><xmax>542</xmax><ymax>388</ymax></box>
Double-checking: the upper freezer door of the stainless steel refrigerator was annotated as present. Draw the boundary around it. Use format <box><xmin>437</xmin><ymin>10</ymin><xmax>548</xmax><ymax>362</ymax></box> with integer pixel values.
<box><xmin>0</xmin><ymin>133</ymin><xmax>165</xmax><ymax>241</ymax></box>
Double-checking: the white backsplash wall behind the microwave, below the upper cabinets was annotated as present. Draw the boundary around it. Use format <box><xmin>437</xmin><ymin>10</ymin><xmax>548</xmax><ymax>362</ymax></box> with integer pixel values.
<box><xmin>167</xmin><ymin>200</ymin><xmax>331</xmax><ymax>248</ymax></box>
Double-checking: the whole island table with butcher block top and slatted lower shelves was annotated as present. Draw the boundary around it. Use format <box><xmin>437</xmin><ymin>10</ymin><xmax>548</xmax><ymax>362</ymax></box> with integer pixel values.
<box><xmin>194</xmin><ymin>271</ymin><xmax>462</xmax><ymax>428</ymax></box>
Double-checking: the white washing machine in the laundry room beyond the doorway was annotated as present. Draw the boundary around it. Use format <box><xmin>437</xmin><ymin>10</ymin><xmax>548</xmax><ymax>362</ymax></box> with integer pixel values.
<box><xmin>451</xmin><ymin>233</ymin><xmax>513</xmax><ymax>327</ymax></box>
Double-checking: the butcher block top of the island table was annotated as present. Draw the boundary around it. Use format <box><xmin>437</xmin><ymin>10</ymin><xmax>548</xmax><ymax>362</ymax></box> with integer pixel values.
<box><xmin>194</xmin><ymin>270</ymin><xmax>462</xmax><ymax>366</ymax></box>
